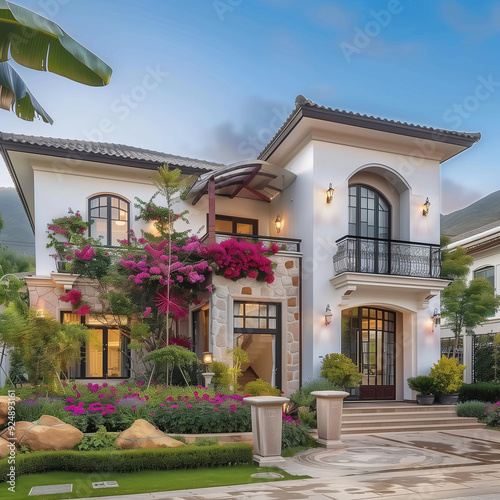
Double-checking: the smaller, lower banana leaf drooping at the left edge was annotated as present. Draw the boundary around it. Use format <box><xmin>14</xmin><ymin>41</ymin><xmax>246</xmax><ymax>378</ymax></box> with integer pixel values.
<box><xmin>0</xmin><ymin>62</ymin><xmax>53</xmax><ymax>124</ymax></box>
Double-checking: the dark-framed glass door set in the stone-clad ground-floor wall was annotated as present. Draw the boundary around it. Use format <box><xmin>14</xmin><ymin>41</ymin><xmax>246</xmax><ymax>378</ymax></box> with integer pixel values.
<box><xmin>233</xmin><ymin>302</ymin><xmax>281</xmax><ymax>389</ymax></box>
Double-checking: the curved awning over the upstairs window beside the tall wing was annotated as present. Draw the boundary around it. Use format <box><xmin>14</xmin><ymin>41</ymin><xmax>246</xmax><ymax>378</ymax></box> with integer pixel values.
<box><xmin>186</xmin><ymin>160</ymin><xmax>296</xmax><ymax>205</ymax></box>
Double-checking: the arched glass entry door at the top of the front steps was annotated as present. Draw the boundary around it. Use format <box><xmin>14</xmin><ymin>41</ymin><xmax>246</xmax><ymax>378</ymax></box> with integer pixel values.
<box><xmin>342</xmin><ymin>307</ymin><xmax>396</xmax><ymax>399</ymax></box>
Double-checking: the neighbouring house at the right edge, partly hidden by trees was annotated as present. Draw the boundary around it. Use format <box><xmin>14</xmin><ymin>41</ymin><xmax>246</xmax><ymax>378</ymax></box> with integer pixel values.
<box><xmin>441</xmin><ymin>221</ymin><xmax>500</xmax><ymax>383</ymax></box>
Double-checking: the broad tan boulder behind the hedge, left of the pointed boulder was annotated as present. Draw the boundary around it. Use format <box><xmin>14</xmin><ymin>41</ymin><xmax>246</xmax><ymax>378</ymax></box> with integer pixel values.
<box><xmin>11</xmin><ymin>415</ymin><xmax>83</xmax><ymax>451</ymax></box>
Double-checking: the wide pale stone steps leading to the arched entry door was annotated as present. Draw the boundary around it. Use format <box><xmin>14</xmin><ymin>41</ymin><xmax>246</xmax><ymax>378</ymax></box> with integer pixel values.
<box><xmin>341</xmin><ymin>402</ymin><xmax>485</xmax><ymax>434</ymax></box>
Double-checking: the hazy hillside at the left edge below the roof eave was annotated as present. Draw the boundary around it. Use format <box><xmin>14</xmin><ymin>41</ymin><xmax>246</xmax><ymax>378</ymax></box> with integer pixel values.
<box><xmin>0</xmin><ymin>187</ymin><xmax>35</xmax><ymax>255</ymax></box>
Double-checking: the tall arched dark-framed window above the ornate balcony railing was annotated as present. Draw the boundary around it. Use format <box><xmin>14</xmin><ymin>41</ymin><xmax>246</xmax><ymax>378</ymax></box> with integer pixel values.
<box><xmin>349</xmin><ymin>184</ymin><xmax>391</xmax><ymax>240</ymax></box>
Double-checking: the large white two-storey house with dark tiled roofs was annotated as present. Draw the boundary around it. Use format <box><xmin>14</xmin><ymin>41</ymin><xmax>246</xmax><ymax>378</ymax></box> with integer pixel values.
<box><xmin>0</xmin><ymin>96</ymin><xmax>480</xmax><ymax>400</ymax></box>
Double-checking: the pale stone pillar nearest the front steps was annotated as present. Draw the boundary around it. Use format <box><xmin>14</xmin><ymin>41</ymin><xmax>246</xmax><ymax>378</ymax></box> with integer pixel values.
<box><xmin>311</xmin><ymin>391</ymin><xmax>349</xmax><ymax>448</ymax></box>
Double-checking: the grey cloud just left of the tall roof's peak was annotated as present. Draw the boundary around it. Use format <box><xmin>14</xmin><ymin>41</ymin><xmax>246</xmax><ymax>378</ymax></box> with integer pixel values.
<box><xmin>192</xmin><ymin>97</ymin><xmax>293</xmax><ymax>163</ymax></box>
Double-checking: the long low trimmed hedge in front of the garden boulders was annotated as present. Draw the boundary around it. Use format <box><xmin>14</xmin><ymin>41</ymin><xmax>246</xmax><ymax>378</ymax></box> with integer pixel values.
<box><xmin>0</xmin><ymin>443</ymin><xmax>253</xmax><ymax>482</ymax></box>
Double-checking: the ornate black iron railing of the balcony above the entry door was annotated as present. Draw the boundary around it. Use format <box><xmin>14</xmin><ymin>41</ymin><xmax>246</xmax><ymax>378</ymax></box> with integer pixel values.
<box><xmin>333</xmin><ymin>236</ymin><xmax>441</xmax><ymax>278</ymax></box>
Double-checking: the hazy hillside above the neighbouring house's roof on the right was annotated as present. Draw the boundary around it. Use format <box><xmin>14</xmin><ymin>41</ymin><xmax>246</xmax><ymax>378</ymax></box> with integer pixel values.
<box><xmin>441</xmin><ymin>191</ymin><xmax>500</xmax><ymax>238</ymax></box>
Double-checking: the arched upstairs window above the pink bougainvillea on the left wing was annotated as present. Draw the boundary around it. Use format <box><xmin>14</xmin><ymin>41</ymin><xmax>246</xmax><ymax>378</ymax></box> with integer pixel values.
<box><xmin>89</xmin><ymin>194</ymin><xmax>130</xmax><ymax>246</ymax></box>
